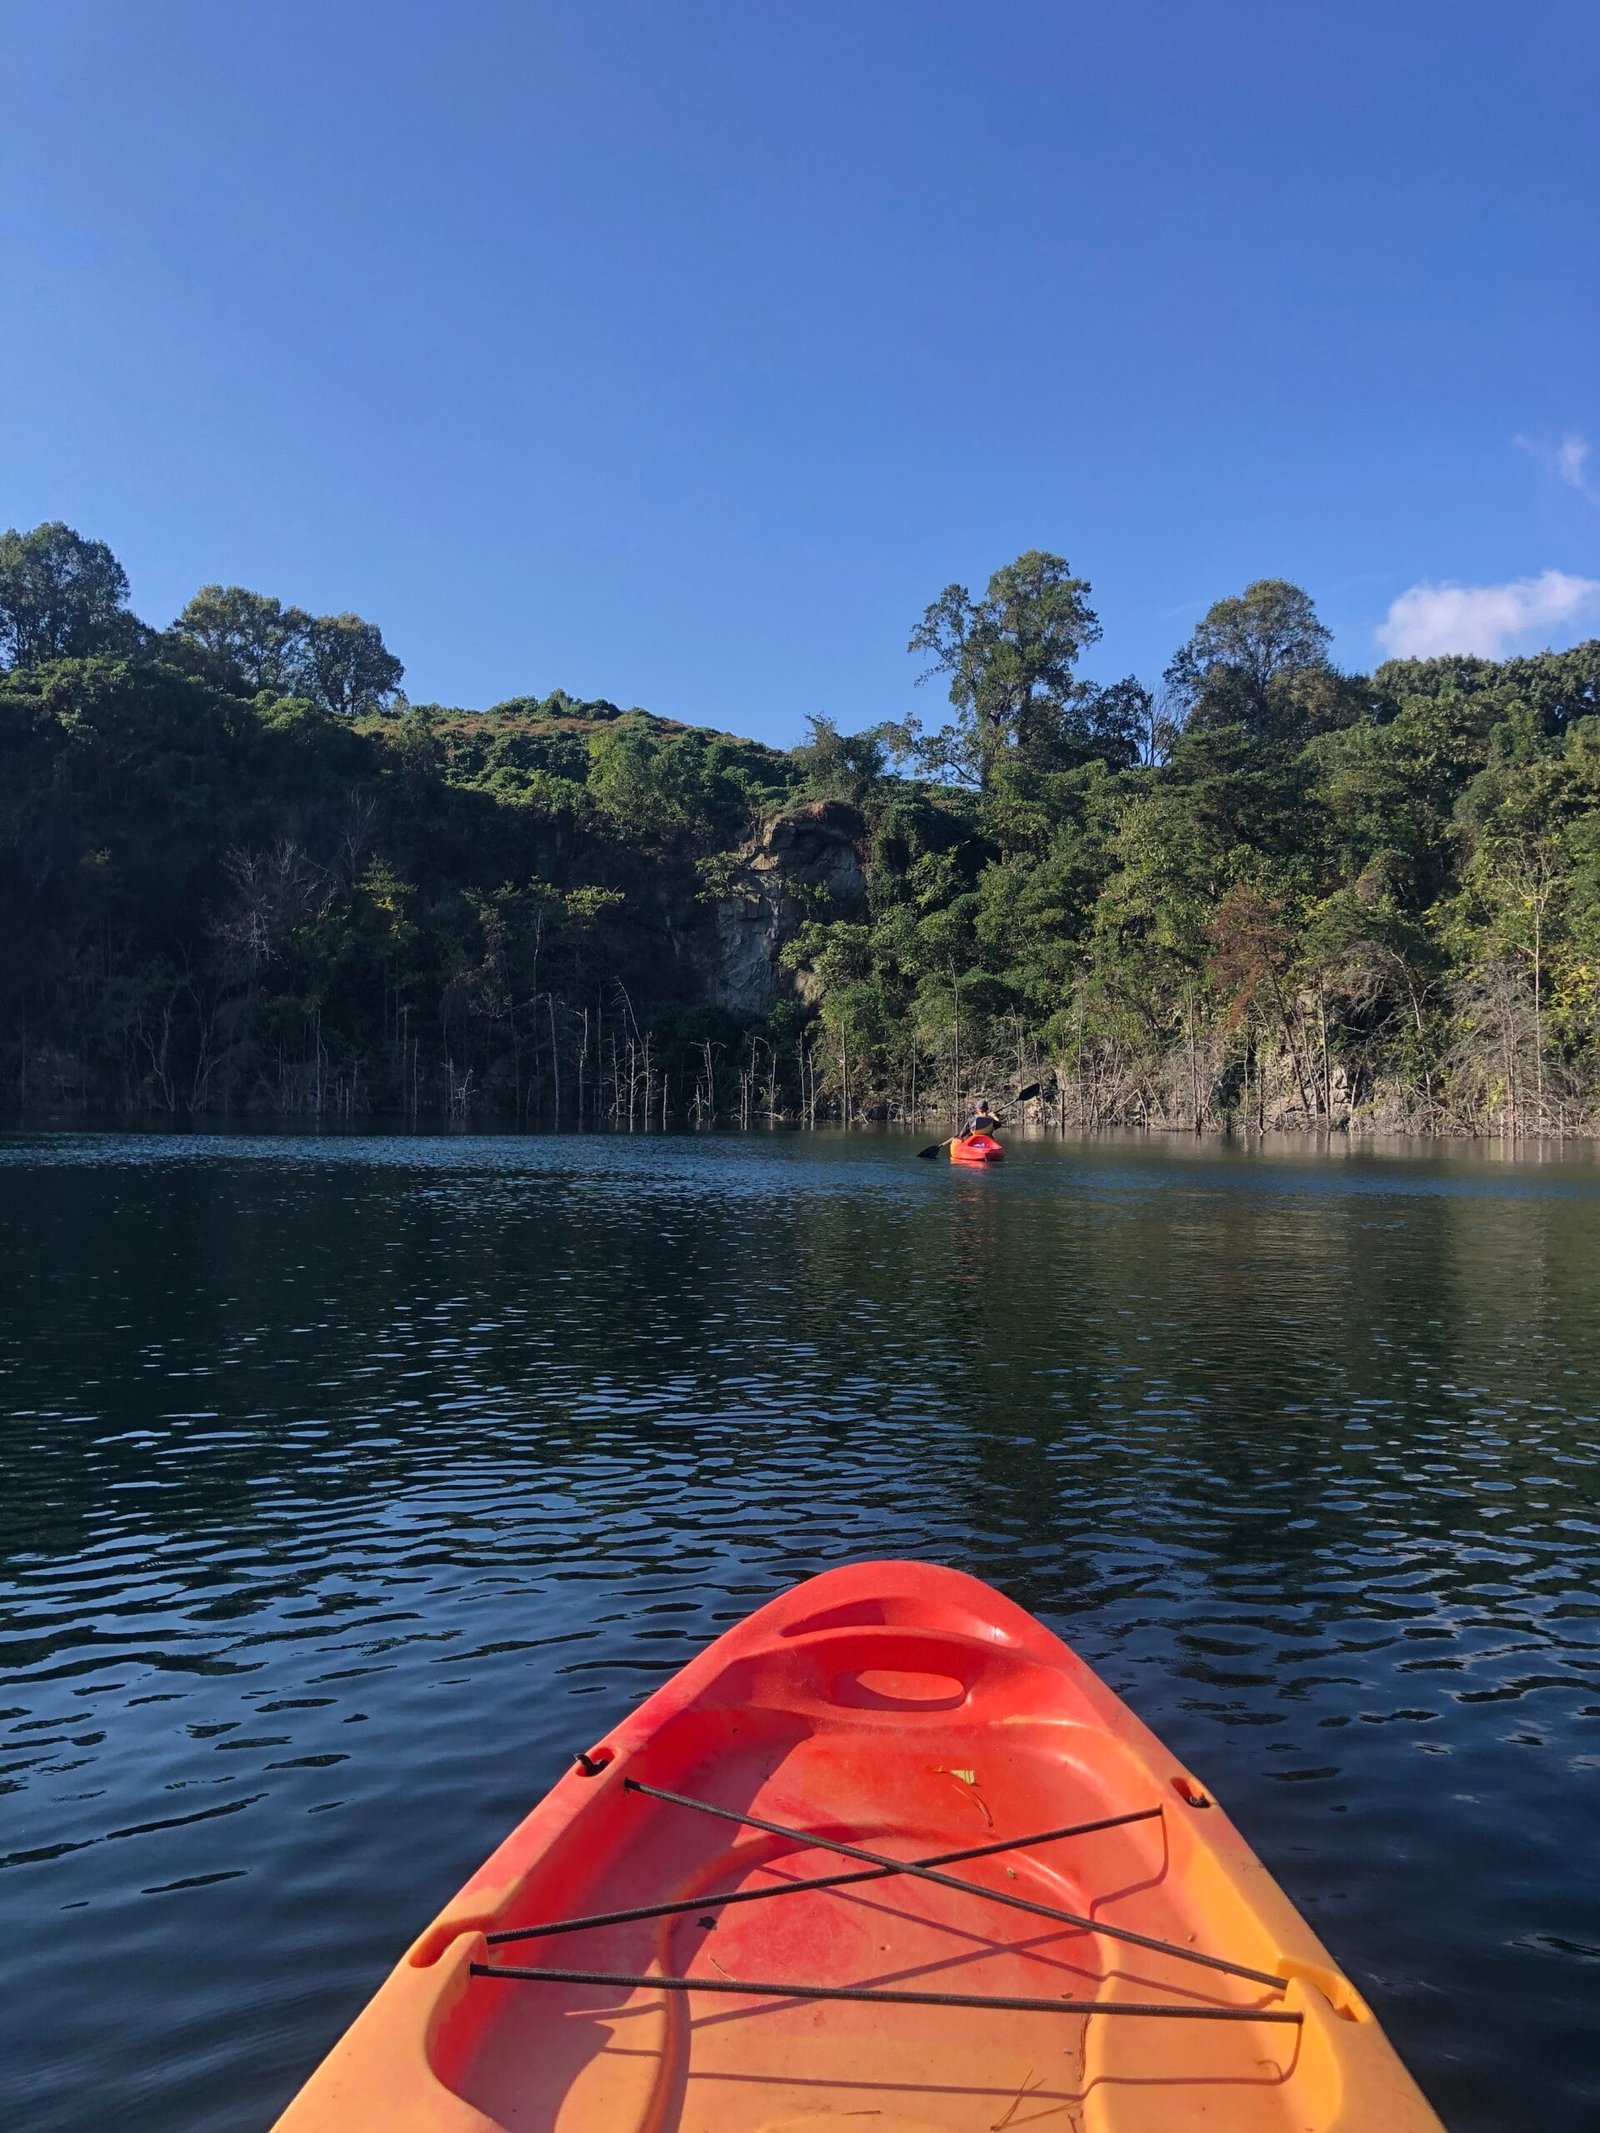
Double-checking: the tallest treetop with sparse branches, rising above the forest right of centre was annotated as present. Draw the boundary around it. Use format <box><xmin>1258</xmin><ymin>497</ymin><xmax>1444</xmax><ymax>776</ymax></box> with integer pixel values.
<box><xmin>907</xmin><ymin>548</ymin><xmax>1101</xmax><ymax>791</ymax></box>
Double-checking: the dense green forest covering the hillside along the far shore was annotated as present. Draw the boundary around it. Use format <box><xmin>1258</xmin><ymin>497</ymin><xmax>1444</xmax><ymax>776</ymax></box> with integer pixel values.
<box><xmin>0</xmin><ymin>525</ymin><xmax>1600</xmax><ymax>1137</ymax></box>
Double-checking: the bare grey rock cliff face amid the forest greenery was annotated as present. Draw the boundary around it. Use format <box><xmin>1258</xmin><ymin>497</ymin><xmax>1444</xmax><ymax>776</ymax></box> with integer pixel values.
<box><xmin>706</xmin><ymin>800</ymin><xmax>866</xmax><ymax>1015</ymax></box>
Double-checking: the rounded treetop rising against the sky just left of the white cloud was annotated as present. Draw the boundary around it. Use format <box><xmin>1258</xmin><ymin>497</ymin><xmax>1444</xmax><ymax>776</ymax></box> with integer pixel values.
<box><xmin>1165</xmin><ymin>578</ymin><xmax>1338</xmax><ymax>740</ymax></box>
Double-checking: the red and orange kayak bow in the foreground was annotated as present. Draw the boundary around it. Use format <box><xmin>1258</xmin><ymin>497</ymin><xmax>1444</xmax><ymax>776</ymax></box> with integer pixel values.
<box><xmin>279</xmin><ymin>1563</ymin><xmax>1440</xmax><ymax>2133</ymax></box>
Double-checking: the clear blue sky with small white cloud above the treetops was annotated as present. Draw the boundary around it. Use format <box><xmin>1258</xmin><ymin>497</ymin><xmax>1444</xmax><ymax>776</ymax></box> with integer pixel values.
<box><xmin>0</xmin><ymin>0</ymin><xmax>1600</xmax><ymax>742</ymax></box>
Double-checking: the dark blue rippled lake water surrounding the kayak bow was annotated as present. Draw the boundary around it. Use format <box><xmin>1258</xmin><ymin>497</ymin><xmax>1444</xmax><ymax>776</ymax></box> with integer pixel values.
<box><xmin>0</xmin><ymin>1135</ymin><xmax>1600</xmax><ymax>2133</ymax></box>
